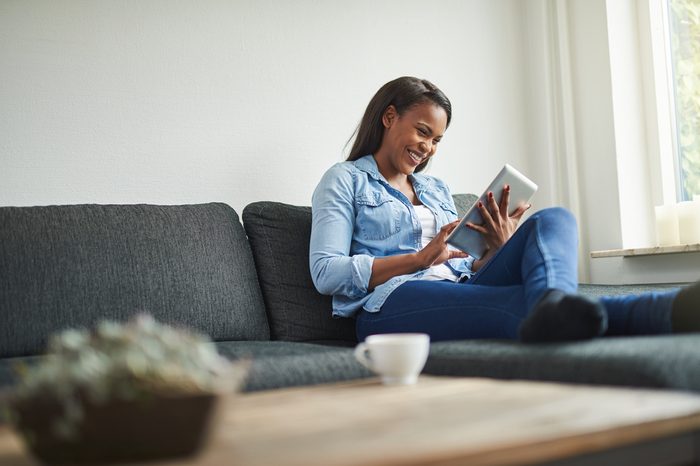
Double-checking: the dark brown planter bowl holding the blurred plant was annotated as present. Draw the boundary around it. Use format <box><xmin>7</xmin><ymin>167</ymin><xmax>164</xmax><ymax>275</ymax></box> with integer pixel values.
<box><xmin>13</xmin><ymin>394</ymin><xmax>218</xmax><ymax>464</ymax></box>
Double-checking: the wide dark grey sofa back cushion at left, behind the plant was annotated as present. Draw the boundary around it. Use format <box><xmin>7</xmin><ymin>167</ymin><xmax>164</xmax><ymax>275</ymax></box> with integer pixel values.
<box><xmin>0</xmin><ymin>203</ymin><xmax>269</xmax><ymax>357</ymax></box>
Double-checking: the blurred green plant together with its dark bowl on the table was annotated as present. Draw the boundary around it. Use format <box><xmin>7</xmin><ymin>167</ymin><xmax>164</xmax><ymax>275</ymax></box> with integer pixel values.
<box><xmin>2</xmin><ymin>315</ymin><xmax>247</xmax><ymax>464</ymax></box>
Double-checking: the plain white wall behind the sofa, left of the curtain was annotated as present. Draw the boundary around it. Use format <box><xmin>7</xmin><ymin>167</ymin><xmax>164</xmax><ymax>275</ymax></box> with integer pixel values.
<box><xmin>0</xmin><ymin>0</ymin><xmax>542</xmax><ymax>212</ymax></box>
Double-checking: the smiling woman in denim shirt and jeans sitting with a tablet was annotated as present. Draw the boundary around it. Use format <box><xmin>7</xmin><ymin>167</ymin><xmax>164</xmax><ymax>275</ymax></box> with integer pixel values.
<box><xmin>310</xmin><ymin>77</ymin><xmax>700</xmax><ymax>342</ymax></box>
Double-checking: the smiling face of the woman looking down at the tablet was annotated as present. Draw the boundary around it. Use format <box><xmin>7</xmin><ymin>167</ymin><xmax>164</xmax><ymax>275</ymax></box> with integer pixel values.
<box><xmin>375</xmin><ymin>102</ymin><xmax>447</xmax><ymax>176</ymax></box>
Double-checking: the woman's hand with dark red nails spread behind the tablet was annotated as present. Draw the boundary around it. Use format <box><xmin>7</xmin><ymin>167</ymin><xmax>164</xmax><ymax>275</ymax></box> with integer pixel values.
<box><xmin>466</xmin><ymin>185</ymin><xmax>530</xmax><ymax>256</ymax></box>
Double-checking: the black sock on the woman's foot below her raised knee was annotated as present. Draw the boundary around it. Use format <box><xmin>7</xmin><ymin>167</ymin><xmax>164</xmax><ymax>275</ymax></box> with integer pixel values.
<box><xmin>519</xmin><ymin>290</ymin><xmax>608</xmax><ymax>343</ymax></box>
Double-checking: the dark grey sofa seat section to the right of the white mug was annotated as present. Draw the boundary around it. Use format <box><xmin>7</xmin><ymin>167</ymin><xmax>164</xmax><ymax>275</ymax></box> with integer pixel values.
<box><xmin>425</xmin><ymin>334</ymin><xmax>700</xmax><ymax>392</ymax></box>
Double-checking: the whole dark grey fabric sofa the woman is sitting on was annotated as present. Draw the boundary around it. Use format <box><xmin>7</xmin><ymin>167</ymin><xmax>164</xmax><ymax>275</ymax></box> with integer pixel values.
<box><xmin>0</xmin><ymin>195</ymin><xmax>700</xmax><ymax>391</ymax></box>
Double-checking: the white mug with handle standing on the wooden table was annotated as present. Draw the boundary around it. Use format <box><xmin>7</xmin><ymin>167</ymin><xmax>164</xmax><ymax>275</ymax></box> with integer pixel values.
<box><xmin>355</xmin><ymin>333</ymin><xmax>430</xmax><ymax>385</ymax></box>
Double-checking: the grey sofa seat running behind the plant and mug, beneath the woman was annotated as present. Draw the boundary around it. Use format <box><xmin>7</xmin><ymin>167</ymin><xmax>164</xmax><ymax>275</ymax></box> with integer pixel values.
<box><xmin>5</xmin><ymin>334</ymin><xmax>700</xmax><ymax>393</ymax></box>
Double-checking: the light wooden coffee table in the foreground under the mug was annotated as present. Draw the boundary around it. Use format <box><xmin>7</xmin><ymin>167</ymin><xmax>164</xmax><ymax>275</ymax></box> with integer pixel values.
<box><xmin>0</xmin><ymin>377</ymin><xmax>700</xmax><ymax>466</ymax></box>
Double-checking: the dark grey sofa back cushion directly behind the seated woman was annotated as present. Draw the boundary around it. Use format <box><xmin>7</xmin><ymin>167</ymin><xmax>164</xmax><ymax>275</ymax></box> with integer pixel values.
<box><xmin>242</xmin><ymin>194</ymin><xmax>476</xmax><ymax>345</ymax></box>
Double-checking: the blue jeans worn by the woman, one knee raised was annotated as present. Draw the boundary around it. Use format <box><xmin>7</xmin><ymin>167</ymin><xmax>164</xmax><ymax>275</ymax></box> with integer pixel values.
<box><xmin>356</xmin><ymin>208</ymin><xmax>678</xmax><ymax>341</ymax></box>
